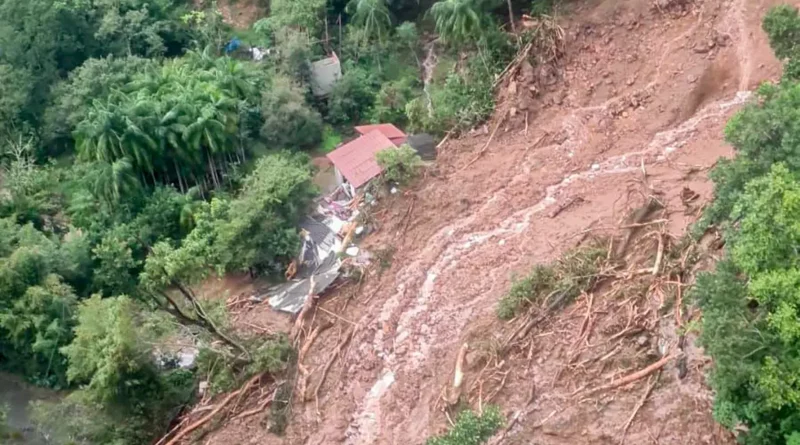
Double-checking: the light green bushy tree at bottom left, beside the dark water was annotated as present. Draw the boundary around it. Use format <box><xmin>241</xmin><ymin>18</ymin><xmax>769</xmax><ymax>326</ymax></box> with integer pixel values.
<box><xmin>34</xmin><ymin>297</ymin><xmax>194</xmax><ymax>444</ymax></box>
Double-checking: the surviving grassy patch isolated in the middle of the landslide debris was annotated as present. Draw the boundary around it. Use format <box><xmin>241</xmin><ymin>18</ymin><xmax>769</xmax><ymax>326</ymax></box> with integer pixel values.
<box><xmin>497</xmin><ymin>242</ymin><xmax>608</xmax><ymax>320</ymax></box>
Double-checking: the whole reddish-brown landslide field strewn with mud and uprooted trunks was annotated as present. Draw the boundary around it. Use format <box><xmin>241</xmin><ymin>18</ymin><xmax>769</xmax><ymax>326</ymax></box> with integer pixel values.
<box><xmin>202</xmin><ymin>0</ymin><xmax>780</xmax><ymax>445</ymax></box>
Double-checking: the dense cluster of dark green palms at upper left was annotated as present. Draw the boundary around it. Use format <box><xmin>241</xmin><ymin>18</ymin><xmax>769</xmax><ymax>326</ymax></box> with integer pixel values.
<box><xmin>74</xmin><ymin>53</ymin><xmax>262</xmax><ymax>190</ymax></box>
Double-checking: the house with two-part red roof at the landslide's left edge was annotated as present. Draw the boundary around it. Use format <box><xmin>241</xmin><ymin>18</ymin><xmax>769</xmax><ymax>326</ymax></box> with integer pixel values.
<box><xmin>327</xmin><ymin>124</ymin><xmax>407</xmax><ymax>189</ymax></box>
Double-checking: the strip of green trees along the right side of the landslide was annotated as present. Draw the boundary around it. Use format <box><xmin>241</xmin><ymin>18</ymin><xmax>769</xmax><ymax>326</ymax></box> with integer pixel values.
<box><xmin>693</xmin><ymin>6</ymin><xmax>800</xmax><ymax>445</ymax></box>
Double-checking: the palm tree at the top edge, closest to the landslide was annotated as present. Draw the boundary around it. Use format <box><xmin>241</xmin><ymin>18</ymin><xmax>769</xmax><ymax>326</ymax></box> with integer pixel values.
<box><xmin>429</xmin><ymin>0</ymin><xmax>484</xmax><ymax>43</ymax></box>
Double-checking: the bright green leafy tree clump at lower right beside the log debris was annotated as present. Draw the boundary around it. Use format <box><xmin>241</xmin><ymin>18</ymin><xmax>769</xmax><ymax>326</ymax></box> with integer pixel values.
<box><xmin>694</xmin><ymin>164</ymin><xmax>800</xmax><ymax>445</ymax></box>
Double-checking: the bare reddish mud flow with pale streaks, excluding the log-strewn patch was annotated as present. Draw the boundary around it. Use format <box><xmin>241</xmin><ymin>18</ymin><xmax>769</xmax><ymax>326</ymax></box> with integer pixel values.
<box><xmin>209</xmin><ymin>0</ymin><xmax>780</xmax><ymax>445</ymax></box>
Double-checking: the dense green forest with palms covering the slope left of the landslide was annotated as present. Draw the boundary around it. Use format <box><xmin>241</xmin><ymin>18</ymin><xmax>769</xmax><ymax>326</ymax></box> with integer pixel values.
<box><xmin>0</xmin><ymin>0</ymin><xmax>545</xmax><ymax>444</ymax></box>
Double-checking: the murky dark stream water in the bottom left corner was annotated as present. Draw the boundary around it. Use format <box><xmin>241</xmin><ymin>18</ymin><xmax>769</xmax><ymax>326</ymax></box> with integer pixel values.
<box><xmin>0</xmin><ymin>372</ymin><xmax>58</xmax><ymax>445</ymax></box>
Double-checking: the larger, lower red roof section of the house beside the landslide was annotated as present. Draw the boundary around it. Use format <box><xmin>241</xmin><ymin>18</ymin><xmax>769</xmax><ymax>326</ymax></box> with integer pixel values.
<box><xmin>328</xmin><ymin>130</ymin><xmax>395</xmax><ymax>188</ymax></box>
